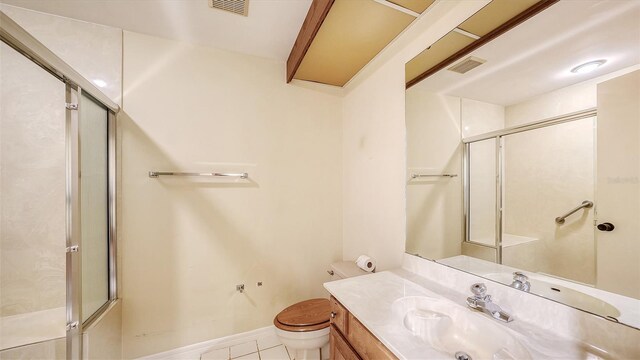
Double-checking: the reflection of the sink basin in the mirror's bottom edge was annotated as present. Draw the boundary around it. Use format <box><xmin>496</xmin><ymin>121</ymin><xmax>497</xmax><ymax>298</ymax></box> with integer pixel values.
<box><xmin>484</xmin><ymin>273</ymin><xmax>620</xmax><ymax>319</ymax></box>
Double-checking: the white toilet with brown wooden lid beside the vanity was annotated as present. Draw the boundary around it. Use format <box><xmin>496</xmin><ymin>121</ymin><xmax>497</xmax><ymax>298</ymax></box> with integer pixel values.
<box><xmin>273</xmin><ymin>261</ymin><xmax>368</xmax><ymax>360</ymax></box>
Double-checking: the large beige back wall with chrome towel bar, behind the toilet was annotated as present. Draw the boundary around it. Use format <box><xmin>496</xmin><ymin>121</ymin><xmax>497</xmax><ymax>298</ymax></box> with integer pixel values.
<box><xmin>120</xmin><ymin>32</ymin><xmax>342</xmax><ymax>358</ymax></box>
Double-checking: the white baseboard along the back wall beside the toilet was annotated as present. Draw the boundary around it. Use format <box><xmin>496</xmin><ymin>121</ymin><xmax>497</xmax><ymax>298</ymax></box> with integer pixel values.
<box><xmin>137</xmin><ymin>325</ymin><xmax>275</xmax><ymax>360</ymax></box>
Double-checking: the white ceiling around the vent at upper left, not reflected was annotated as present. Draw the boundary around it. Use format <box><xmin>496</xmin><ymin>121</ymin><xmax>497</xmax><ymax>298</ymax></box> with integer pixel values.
<box><xmin>0</xmin><ymin>0</ymin><xmax>311</xmax><ymax>61</ymax></box>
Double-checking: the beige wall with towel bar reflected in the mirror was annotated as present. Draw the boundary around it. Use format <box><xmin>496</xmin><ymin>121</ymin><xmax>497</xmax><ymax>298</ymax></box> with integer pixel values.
<box><xmin>405</xmin><ymin>86</ymin><xmax>462</xmax><ymax>259</ymax></box>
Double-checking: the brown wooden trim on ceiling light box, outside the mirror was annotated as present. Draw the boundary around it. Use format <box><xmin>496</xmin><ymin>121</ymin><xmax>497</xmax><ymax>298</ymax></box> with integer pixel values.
<box><xmin>287</xmin><ymin>0</ymin><xmax>335</xmax><ymax>83</ymax></box>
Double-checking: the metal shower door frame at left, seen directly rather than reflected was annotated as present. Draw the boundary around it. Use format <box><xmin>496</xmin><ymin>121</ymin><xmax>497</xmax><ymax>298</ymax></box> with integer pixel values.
<box><xmin>0</xmin><ymin>11</ymin><xmax>120</xmax><ymax>359</ymax></box>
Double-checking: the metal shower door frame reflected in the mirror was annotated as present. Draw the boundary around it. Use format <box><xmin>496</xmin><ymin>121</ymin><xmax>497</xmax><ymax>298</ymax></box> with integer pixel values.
<box><xmin>462</xmin><ymin>107</ymin><xmax>598</xmax><ymax>264</ymax></box>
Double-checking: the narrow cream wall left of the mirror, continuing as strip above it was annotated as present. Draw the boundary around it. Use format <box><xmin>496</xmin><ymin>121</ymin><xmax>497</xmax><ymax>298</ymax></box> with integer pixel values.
<box><xmin>342</xmin><ymin>1</ymin><xmax>488</xmax><ymax>269</ymax></box>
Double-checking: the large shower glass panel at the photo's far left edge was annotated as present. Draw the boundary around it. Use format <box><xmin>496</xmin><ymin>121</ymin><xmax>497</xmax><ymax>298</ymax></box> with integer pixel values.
<box><xmin>0</xmin><ymin>42</ymin><xmax>66</xmax><ymax>352</ymax></box>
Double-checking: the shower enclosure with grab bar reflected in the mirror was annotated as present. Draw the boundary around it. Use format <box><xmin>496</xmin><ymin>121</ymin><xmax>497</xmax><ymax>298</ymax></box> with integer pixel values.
<box><xmin>463</xmin><ymin>109</ymin><xmax>596</xmax><ymax>285</ymax></box>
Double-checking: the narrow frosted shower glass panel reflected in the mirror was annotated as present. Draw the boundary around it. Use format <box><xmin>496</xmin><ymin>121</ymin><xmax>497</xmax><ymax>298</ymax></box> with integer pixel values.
<box><xmin>469</xmin><ymin>139</ymin><xmax>496</xmax><ymax>248</ymax></box>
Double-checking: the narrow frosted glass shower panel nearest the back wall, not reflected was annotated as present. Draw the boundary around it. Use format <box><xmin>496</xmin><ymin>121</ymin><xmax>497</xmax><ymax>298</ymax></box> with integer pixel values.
<box><xmin>80</xmin><ymin>94</ymin><xmax>109</xmax><ymax>322</ymax></box>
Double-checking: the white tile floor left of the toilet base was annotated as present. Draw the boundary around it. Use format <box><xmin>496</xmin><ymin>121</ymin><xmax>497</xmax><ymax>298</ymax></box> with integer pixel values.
<box><xmin>200</xmin><ymin>334</ymin><xmax>291</xmax><ymax>360</ymax></box>
